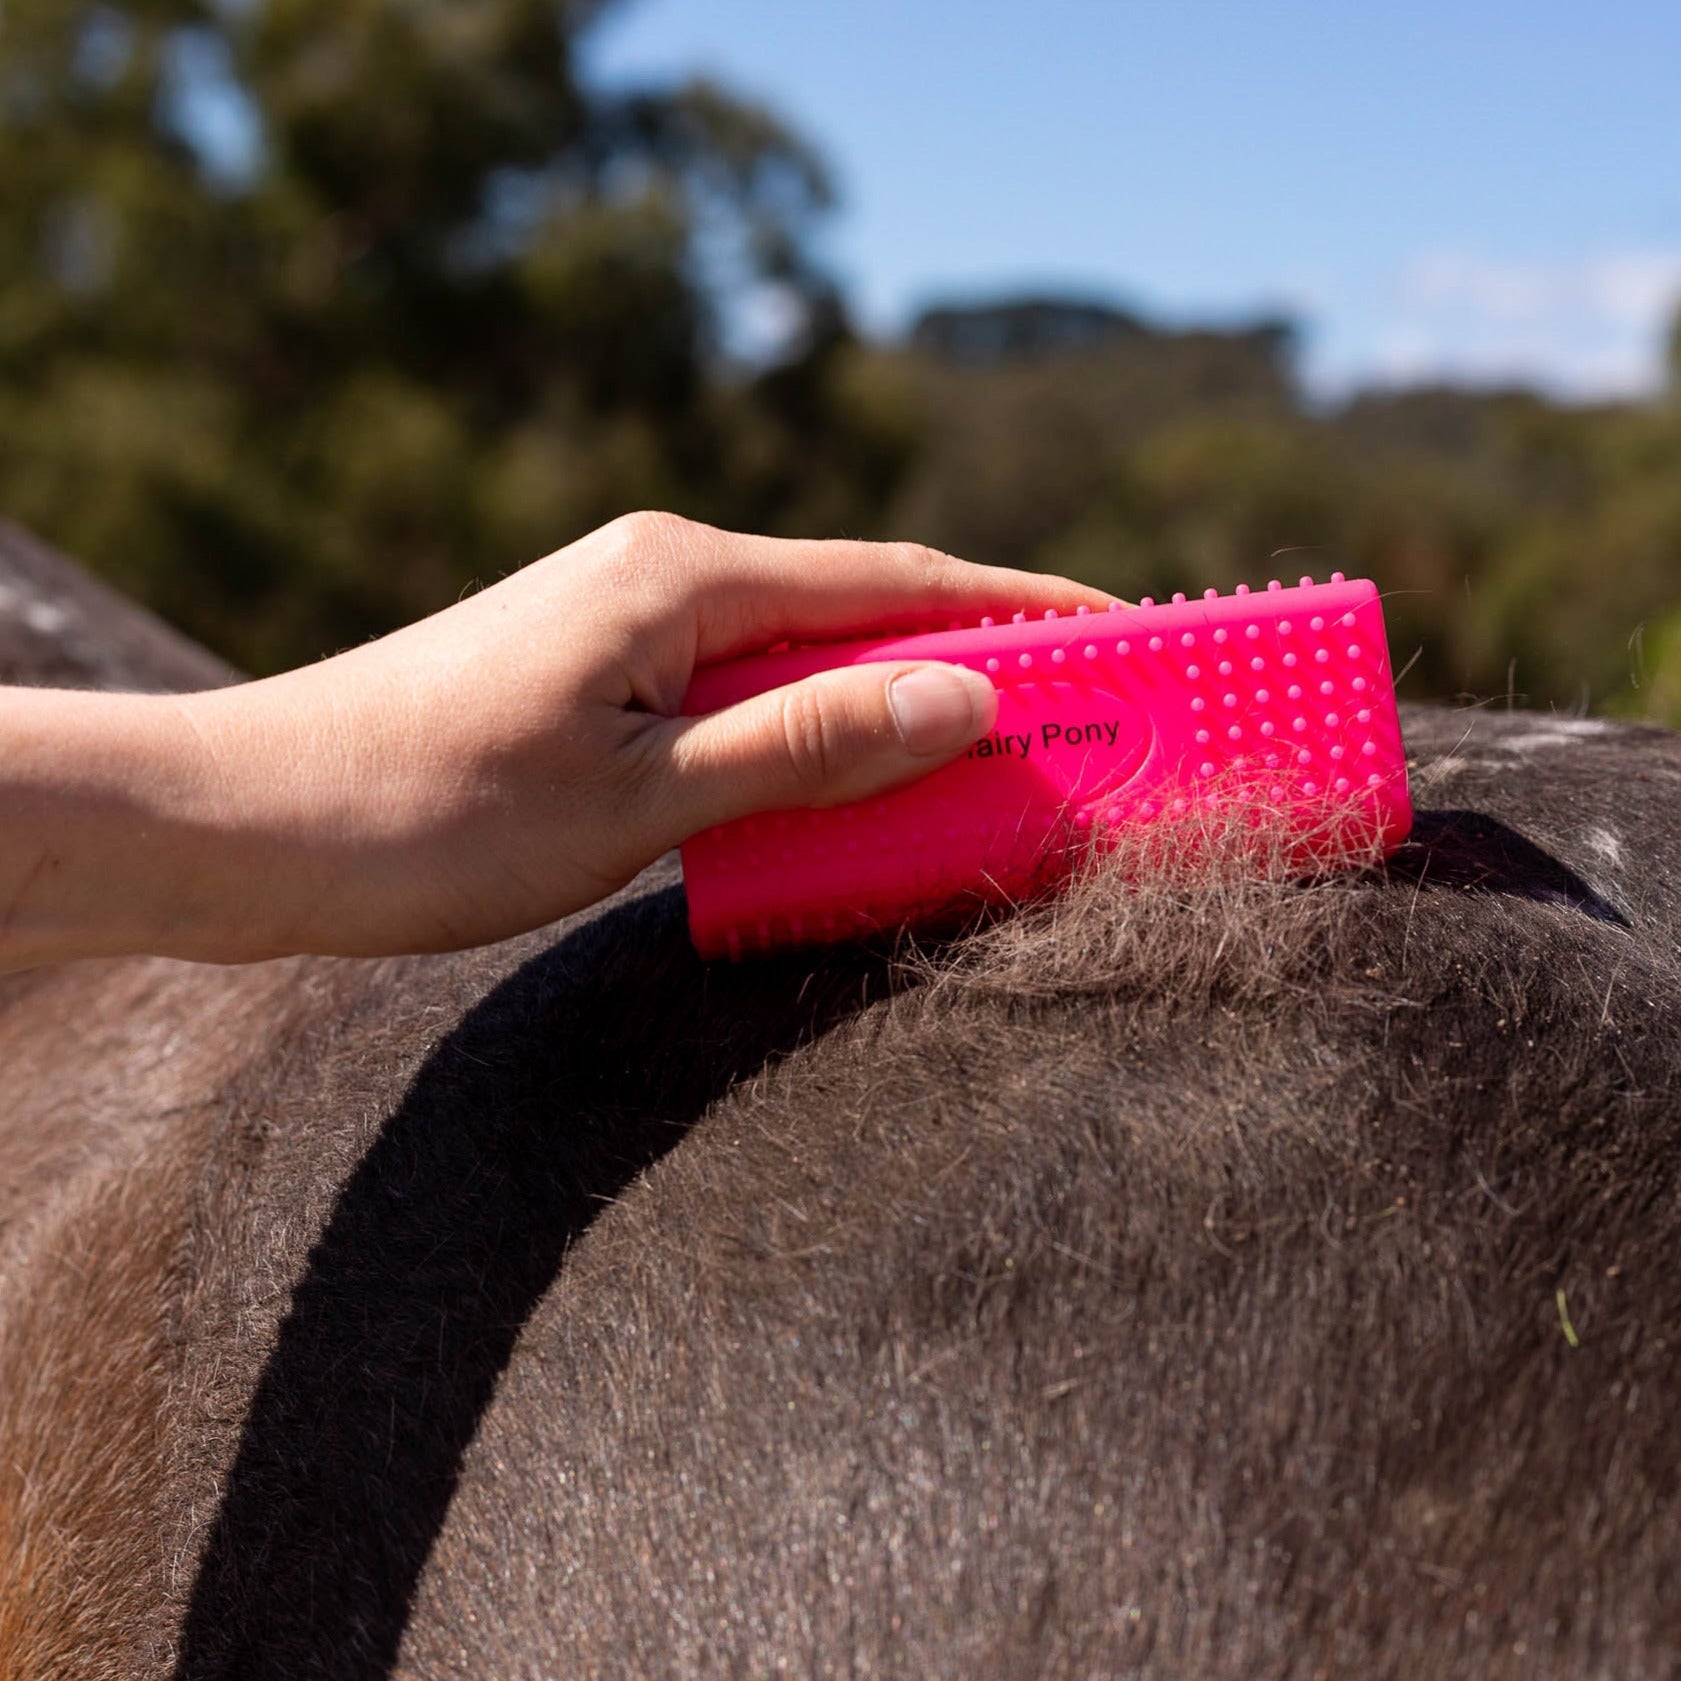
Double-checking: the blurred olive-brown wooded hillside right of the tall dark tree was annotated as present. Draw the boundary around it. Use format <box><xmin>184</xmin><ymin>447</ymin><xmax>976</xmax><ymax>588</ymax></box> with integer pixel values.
<box><xmin>888</xmin><ymin>317</ymin><xmax>1681</xmax><ymax>723</ymax></box>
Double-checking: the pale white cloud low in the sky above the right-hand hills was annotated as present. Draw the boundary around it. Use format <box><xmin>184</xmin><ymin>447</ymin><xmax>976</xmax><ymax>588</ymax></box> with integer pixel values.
<box><xmin>1340</xmin><ymin>249</ymin><xmax>1681</xmax><ymax>398</ymax></box>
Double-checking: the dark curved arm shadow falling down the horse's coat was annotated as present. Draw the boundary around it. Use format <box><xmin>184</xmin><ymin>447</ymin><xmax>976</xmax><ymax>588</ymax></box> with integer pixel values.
<box><xmin>175</xmin><ymin>888</ymin><xmax>888</xmax><ymax>1681</ymax></box>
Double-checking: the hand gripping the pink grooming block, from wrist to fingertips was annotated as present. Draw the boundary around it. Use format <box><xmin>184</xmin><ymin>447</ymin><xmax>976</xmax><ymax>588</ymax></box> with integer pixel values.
<box><xmin>0</xmin><ymin>514</ymin><xmax>1109</xmax><ymax>965</ymax></box>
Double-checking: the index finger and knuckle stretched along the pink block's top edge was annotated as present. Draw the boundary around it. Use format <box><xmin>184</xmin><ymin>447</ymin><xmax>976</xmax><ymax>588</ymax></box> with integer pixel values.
<box><xmin>603</xmin><ymin>514</ymin><xmax>1115</xmax><ymax>664</ymax></box>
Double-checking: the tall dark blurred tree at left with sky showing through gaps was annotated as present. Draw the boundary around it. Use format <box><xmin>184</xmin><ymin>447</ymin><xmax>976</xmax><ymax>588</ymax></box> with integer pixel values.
<box><xmin>0</xmin><ymin>0</ymin><xmax>903</xmax><ymax>669</ymax></box>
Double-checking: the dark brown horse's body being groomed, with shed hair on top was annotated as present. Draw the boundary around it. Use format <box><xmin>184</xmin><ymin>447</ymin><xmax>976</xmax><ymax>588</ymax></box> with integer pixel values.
<box><xmin>0</xmin><ymin>521</ymin><xmax>1681</xmax><ymax>1681</ymax></box>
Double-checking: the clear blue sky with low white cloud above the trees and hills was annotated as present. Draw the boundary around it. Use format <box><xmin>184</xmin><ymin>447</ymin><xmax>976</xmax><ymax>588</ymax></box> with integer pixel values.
<box><xmin>590</xmin><ymin>0</ymin><xmax>1681</xmax><ymax>397</ymax></box>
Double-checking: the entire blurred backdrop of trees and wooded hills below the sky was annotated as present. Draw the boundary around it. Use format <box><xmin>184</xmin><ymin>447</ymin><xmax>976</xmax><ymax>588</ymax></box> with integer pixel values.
<box><xmin>0</xmin><ymin>0</ymin><xmax>1681</xmax><ymax>721</ymax></box>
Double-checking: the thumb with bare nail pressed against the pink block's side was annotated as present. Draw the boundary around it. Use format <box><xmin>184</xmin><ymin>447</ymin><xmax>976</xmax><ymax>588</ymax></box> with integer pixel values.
<box><xmin>645</xmin><ymin>661</ymin><xmax>999</xmax><ymax>839</ymax></box>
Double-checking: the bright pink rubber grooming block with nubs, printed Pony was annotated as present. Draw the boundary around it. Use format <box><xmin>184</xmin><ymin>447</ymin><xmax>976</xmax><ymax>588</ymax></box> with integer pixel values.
<box><xmin>682</xmin><ymin>572</ymin><xmax>1412</xmax><ymax>958</ymax></box>
